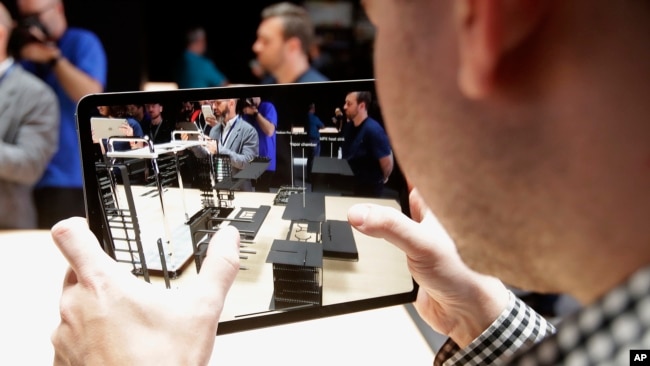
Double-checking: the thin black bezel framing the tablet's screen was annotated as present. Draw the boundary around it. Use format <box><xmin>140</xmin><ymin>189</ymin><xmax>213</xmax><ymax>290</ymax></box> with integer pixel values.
<box><xmin>76</xmin><ymin>79</ymin><xmax>418</xmax><ymax>335</ymax></box>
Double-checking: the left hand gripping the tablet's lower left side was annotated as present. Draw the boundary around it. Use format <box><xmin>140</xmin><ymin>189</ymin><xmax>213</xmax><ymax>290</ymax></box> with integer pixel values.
<box><xmin>52</xmin><ymin>218</ymin><xmax>239</xmax><ymax>365</ymax></box>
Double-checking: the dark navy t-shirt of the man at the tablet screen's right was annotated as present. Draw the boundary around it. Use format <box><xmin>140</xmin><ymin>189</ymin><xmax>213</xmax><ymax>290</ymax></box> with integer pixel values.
<box><xmin>342</xmin><ymin>117</ymin><xmax>391</xmax><ymax>184</ymax></box>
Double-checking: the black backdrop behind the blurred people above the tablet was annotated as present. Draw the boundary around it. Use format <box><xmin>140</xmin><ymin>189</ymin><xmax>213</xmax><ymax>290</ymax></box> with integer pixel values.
<box><xmin>1</xmin><ymin>0</ymin><xmax>372</xmax><ymax>91</ymax></box>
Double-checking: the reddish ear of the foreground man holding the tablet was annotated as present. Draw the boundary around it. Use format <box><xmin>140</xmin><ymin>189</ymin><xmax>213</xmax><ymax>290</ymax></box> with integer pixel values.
<box><xmin>454</xmin><ymin>0</ymin><xmax>549</xmax><ymax>99</ymax></box>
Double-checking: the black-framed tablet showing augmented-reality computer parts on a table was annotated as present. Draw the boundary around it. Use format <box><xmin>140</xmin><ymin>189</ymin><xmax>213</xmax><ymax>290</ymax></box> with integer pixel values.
<box><xmin>76</xmin><ymin>80</ymin><xmax>417</xmax><ymax>334</ymax></box>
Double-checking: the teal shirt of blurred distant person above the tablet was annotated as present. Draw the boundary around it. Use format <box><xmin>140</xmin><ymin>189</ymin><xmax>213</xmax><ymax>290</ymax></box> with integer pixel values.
<box><xmin>176</xmin><ymin>50</ymin><xmax>226</xmax><ymax>89</ymax></box>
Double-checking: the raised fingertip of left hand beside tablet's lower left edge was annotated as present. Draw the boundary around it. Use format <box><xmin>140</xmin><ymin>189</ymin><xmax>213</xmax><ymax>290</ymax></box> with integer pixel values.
<box><xmin>52</xmin><ymin>217</ymin><xmax>113</xmax><ymax>281</ymax></box>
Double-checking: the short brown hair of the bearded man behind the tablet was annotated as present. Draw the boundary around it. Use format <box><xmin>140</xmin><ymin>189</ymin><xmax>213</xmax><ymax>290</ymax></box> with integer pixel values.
<box><xmin>262</xmin><ymin>2</ymin><xmax>314</xmax><ymax>55</ymax></box>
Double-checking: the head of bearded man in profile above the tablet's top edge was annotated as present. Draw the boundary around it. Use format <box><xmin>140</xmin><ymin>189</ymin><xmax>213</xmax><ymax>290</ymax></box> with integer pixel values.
<box><xmin>253</xmin><ymin>2</ymin><xmax>314</xmax><ymax>74</ymax></box>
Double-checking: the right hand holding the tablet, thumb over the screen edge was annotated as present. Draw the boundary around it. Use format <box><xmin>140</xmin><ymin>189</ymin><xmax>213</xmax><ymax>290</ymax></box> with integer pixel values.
<box><xmin>348</xmin><ymin>189</ymin><xmax>509</xmax><ymax>348</ymax></box>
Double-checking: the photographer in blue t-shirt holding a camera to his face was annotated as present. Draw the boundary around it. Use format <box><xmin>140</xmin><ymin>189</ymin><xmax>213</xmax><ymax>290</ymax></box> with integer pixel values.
<box><xmin>13</xmin><ymin>0</ymin><xmax>106</xmax><ymax>229</ymax></box>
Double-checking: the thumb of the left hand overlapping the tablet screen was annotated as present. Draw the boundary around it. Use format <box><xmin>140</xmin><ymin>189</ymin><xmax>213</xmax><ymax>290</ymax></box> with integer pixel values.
<box><xmin>199</xmin><ymin>226</ymin><xmax>239</xmax><ymax>297</ymax></box>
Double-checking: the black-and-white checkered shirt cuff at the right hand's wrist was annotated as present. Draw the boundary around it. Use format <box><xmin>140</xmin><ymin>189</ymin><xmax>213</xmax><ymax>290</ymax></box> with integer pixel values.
<box><xmin>433</xmin><ymin>293</ymin><xmax>555</xmax><ymax>366</ymax></box>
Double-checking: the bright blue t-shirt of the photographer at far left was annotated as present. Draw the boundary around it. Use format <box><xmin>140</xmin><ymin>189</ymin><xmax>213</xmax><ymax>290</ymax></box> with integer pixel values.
<box><xmin>22</xmin><ymin>28</ymin><xmax>107</xmax><ymax>188</ymax></box>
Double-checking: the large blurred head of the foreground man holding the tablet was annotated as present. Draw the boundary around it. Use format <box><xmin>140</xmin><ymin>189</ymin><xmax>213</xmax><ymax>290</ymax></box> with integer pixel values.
<box><xmin>364</xmin><ymin>0</ymin><xmax>650</xmax><ymax>298</ymax></box>
